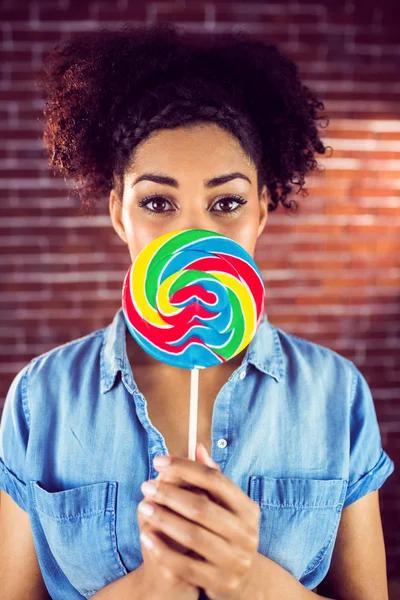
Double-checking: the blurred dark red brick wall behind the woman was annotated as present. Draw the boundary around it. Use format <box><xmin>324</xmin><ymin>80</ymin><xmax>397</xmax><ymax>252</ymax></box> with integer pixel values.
<box><xmin>0</xmin><ymin>0</ymin><xmax>400</xmax><ymax>598</ymax></box>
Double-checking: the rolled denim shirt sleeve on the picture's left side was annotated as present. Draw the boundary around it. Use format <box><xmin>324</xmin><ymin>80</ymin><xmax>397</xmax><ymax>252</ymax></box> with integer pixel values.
<box><xmin>0</xmin><ymin>365</ymin><xmax>29</xmax><ymax>512</ymax></box>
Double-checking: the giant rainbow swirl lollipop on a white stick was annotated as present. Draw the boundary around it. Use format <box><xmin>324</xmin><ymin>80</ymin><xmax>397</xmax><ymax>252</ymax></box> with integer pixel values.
<box><xmin>122</xmin><ymin>229</ymin><xmax>265</xmax><ymax>460</ymax></box>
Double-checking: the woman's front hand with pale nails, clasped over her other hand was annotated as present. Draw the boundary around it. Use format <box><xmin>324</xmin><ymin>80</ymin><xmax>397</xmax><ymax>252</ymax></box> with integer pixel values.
<box><xmin>138</xmin><ymin>447</ymin><xmax>260</xmax><ymax>600</ymax></box>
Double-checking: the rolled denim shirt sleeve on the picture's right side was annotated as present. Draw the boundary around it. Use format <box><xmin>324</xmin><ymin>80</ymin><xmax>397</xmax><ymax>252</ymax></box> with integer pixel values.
<box><xmin>343</xmin><ymin>365</ymin><xmax>394</xmax><ymax>507</ymax></box>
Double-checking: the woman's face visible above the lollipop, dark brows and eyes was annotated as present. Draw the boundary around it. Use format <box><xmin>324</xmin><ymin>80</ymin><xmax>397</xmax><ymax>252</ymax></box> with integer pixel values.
<box><xmin>109</xmin><ymin>123</ymin><xmax>268</xmax><ymax>262</ymax></box>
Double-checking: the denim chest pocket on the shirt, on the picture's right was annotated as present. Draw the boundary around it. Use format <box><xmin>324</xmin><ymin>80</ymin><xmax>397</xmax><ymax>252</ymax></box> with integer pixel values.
<box><xmin>249</xmin><ymin>476</ymin><xmax>347</xmax><ymax>582</ymax></box>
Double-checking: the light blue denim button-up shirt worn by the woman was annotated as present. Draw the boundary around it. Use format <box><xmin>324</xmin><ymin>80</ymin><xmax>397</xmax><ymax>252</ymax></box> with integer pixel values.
<box><xmin>0</xmin><ymin>308</ymin><xmax>394</xmax><ymax>600</ymax></box>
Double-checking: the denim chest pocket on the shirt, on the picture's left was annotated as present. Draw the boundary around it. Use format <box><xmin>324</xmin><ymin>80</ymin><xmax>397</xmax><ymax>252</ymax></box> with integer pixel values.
<box><xmin>30</xmin><ymin>481</ymin><xmax>127</xmax><ymax>598</ymax></box>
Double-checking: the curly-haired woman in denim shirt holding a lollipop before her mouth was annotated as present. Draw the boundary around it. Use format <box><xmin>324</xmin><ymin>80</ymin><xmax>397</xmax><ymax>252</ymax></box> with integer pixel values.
<box><xmin>0</xmin><ymin>25</ymin><xmax>394</xmax><ymax>600</ymax></box>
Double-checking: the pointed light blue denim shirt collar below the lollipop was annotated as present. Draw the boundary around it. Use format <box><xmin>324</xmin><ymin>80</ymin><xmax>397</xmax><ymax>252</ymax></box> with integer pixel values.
<box><xmin>100</xmin><ymin>306</ymin><xmax>284</xmax><ymax>394</ymax></box>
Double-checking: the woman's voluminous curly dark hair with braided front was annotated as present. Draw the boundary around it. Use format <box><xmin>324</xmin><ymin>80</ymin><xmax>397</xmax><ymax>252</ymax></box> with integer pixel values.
<box><xmin>38</xmin><ymin>23</ymin><xmax>329</xmax><ymax>217</ymax></box>
